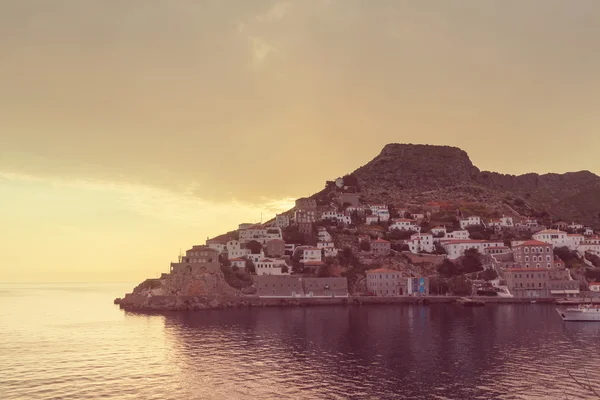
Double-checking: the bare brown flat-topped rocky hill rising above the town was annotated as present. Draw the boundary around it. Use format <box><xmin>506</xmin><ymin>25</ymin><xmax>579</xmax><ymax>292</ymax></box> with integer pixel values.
<box><xmin>346</xmin><ymin>144</ymin><xmax>600</xmax><ymax>227</ymax></box>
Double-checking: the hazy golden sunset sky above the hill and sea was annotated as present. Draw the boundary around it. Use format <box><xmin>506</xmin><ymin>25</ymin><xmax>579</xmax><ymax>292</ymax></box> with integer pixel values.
<box><xmin>0</xmin><ymin>0</ymin><xmax>600</xmax><ymax>282</ymax></box>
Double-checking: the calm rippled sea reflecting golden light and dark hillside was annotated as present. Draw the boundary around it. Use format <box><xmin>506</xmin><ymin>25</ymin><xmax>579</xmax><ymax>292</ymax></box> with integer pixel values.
<box><xmin>0</xmin><ymin>284</ymin><xmax>600</xmax><ymax>400</ymax></box>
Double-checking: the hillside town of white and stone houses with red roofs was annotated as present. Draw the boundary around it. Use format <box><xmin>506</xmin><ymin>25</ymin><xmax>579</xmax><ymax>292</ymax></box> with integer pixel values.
<box><xmin>137</xmin><ymin>175</ymin><xmax>600</xmax><ymax>298</ymax></box>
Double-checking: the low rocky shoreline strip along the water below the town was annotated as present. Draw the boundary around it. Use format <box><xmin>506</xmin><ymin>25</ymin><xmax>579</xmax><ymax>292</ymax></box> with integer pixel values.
<box><xmin>115</xmin><ymin>294</ymin><xmax>600</xmax><ymax>312</ymax></box>
